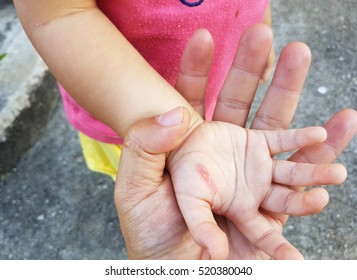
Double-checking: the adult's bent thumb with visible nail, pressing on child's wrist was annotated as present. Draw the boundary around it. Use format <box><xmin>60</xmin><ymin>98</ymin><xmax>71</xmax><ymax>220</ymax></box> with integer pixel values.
<box><xmin>116</xmin><ymin>107</ymin><xmax>190</xmax><ymax>195</ymax></box>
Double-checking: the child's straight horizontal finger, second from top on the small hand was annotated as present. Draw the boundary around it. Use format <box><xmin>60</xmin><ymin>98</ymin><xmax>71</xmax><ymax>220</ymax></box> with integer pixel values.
<box><xmin>272</xmin><ymin>160</ymin><xmax>347</xmax><ymax>186</ymax></box>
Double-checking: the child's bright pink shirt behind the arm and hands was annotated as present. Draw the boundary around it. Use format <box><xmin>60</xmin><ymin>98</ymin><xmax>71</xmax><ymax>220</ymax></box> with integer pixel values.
<box><xmin>60</xmin><ymin>0</ymin><xmax>268</xmax><ymax>144</ymax></box>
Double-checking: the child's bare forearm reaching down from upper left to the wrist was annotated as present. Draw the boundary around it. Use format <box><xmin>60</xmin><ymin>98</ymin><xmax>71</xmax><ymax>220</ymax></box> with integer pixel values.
<box><xmin>14</xmin><ymin>0</ymin><xmax>202</xmax><ymax>135</ymax></box>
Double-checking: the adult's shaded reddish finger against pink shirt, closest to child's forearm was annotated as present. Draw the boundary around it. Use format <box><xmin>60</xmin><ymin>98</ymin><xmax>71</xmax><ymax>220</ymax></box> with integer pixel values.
<box><xmin>175</xmin><ymin>29</ymin><xmax>214</xmax><ymax>118</ymax></box>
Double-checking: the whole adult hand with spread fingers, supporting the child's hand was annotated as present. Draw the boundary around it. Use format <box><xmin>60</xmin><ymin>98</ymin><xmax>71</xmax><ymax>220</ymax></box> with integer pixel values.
<box><xmin>115</xmin><ymin>26</ymin><xmax>357</xmax><ymax>259</ymax></box>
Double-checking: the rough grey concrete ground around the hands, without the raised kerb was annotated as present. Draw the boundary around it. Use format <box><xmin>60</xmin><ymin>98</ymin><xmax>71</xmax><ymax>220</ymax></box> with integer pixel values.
<box><xmin>0</xmin><ymin>0</ymin><xmax>357</xmax><ymax>259</ymax></box>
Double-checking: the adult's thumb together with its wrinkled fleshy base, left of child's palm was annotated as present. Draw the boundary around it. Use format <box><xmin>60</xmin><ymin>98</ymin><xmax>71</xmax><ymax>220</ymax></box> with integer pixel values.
<box><xmin>114</xmin><ymin>108</ymin><xmax>205</xmax><ymax>259</ymax></box>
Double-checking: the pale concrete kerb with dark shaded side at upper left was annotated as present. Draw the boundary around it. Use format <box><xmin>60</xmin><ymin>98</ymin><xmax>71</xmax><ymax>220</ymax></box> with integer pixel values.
<box><xmin>0</xmin><ymin>0</ymin><xmax>58</xmax><ymax>174</ymax></box>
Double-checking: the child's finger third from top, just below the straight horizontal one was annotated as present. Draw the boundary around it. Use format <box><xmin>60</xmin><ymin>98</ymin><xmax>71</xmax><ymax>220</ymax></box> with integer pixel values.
<box><xmin>260</xmin><ymin>185</ymin><xmax>329</xmax><ymax>216</ymax></box>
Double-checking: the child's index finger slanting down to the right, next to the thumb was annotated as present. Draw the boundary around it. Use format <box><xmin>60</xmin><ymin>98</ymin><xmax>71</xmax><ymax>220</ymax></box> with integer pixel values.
<box><xmin>236</xmin><ymin>212</ymin><xmax>304</xmax><ymax>260</ymax></box>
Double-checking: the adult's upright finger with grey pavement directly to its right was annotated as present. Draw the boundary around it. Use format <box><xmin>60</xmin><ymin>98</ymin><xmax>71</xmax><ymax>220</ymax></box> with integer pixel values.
<box><xmin>251</xmin><ymin>43</ymin><xmax>311</xmax><ymax>130</ymax></box>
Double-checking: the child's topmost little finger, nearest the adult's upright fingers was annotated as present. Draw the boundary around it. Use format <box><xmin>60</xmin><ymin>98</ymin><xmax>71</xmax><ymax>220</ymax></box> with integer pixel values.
<box><xmin>263</xmin><ymin>127</ymin><xmax>327</xmax><ymax>155</ymax></box>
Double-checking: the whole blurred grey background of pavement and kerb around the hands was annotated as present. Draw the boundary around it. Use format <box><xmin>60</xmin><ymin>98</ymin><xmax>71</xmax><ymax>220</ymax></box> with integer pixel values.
<box><xmin>0</xmin><ymin>0</ymin><xmax>357</xmax><ymax>260</ymax></box>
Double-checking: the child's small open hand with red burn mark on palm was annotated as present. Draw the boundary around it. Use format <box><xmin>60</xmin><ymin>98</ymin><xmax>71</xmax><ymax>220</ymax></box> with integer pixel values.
<box><xmin>167</xmin><ymin>122</ymin><xmax>346</xmax><ymax>259</ymax></box>
